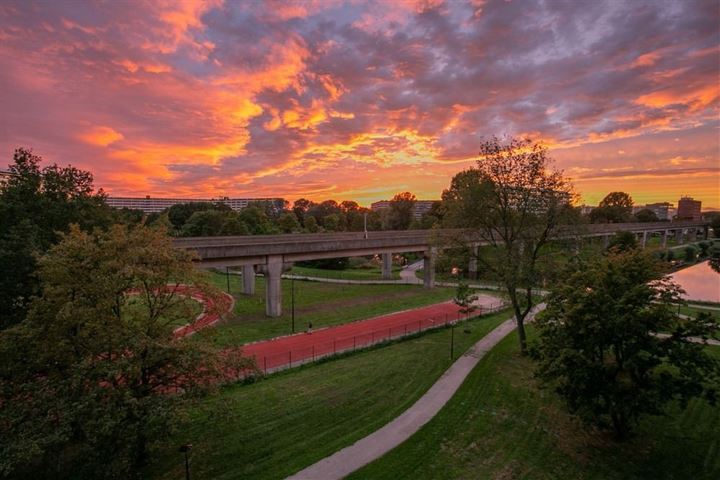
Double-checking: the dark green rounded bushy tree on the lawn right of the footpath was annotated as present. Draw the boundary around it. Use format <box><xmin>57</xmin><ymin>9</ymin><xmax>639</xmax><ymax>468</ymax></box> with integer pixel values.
<box><xmin>533</xmin><ymin>250</ymin><xmax>720</xmax><ymax>438</ymax></box>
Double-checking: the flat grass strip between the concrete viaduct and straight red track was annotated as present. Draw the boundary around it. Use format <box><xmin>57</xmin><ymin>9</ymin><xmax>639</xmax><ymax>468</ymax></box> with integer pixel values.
<box><xmin>205</xmin><ymin>273</ymin><xmax>455</xmax><ymax>346</ymax></box>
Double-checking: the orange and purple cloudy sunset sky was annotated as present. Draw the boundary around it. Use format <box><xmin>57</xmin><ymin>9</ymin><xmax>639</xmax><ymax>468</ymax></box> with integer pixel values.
<box><xmin>0</xmin><ymin>0</ymin><xmax>720</xmax><ymax>208</ymax></box>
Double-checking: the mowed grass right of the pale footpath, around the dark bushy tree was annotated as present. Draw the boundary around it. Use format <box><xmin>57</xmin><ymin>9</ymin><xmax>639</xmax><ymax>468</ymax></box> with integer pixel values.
<box><xmin>349</xmin><ymin>328</ymin><xmax>720</xmax><ymax>480</ymax></box>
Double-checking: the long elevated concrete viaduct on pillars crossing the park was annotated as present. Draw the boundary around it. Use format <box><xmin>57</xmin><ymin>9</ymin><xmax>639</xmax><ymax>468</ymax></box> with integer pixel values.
<box><xmin>173</xmin><ymin>221</ymin><xmax>708</xmax><ymax>317</ymax></box>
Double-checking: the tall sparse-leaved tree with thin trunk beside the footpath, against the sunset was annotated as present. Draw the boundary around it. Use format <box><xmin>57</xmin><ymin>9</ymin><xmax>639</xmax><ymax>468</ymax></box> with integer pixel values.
<box><xmin>443</xmin><ymin>137</ymin><xmax>573</xmax><ymax>354</ymax></box>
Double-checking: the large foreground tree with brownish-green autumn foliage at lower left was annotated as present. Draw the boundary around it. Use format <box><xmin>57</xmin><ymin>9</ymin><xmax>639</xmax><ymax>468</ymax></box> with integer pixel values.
<box><xmin>0</xmin><ymin>225</ymin><xmax>245</xmax><ymax>478</ymax></box>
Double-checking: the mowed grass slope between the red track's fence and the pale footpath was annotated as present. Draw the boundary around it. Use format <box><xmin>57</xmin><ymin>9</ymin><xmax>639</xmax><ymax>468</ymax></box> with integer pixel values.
<box><xmin>148</xmin><ymin>311</ymin><xmax>510</xmax><ymax>479</ymax></box>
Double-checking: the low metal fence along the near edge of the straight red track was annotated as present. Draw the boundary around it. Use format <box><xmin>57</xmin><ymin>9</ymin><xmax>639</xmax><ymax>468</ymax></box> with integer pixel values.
<box><xmin>254</xmin><ymin>302</ymin><xmax>505</xmax><ymax>374</ymax></box>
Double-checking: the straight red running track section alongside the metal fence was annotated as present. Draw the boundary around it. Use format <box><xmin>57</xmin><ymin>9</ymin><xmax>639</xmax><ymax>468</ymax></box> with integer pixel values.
<box><xmin>242</xmin><ymin>302</ymin><xmax>482</xmax><ymax>373</ymax></box>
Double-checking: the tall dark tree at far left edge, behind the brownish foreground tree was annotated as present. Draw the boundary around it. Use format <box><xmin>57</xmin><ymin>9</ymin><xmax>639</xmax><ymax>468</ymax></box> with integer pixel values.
<box><xmin>0</xmin><ymin>148</ymin><xmax>111</xmax><ymax>329</ymax></box>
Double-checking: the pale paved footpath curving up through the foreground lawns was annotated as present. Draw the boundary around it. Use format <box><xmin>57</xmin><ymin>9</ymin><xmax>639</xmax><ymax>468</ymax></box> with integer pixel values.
<box><xmin>289</xmin><ymin>304</ymin><xmax>545</xmax><ymax>480</ymax></box>
